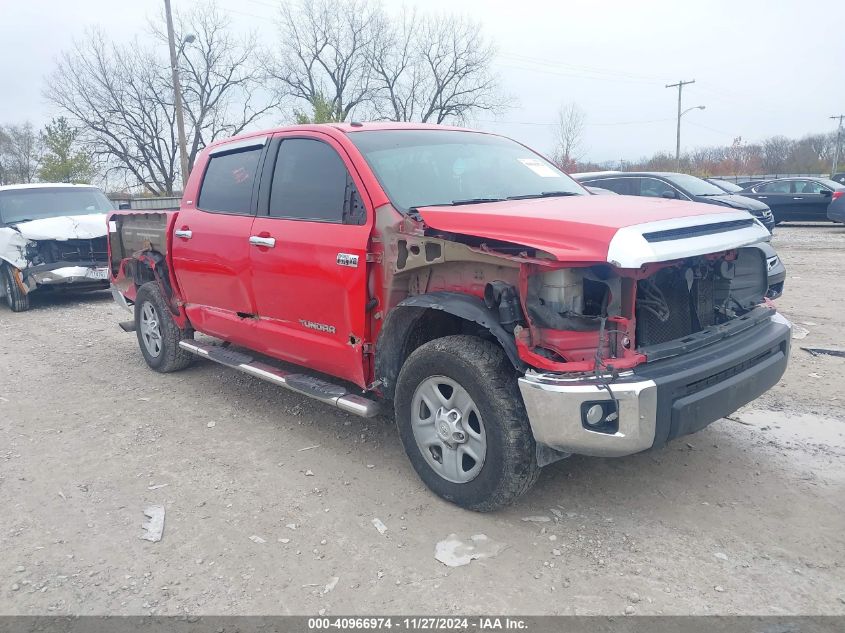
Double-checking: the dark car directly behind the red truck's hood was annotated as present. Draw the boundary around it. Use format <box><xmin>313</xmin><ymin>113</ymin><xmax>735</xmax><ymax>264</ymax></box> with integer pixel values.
<box><xmin>570</xmin><ymin>171</ymin><xmax>786</xmax><ymax>299</ymax></box>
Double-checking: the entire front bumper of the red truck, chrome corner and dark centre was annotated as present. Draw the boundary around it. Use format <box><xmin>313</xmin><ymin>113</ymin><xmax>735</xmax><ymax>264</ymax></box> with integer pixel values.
<box><xmin>519</xmin><ymin>313</ymin><xmax>792</xmax><ymax>457</ymax></box>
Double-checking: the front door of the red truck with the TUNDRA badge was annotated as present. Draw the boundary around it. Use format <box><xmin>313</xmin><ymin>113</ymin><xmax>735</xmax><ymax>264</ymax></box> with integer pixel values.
<box><xmin>249</xmin><ymin>134</ymin><xmax>372</xmax><ymax>386</ymax></box>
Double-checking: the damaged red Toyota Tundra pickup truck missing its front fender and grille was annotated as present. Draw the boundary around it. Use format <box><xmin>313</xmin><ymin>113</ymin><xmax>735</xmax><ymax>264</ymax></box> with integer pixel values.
<box><xmin>109</xmin><ymin>123</ymin><xmax>791</xmax><ymax>510</ymax></box>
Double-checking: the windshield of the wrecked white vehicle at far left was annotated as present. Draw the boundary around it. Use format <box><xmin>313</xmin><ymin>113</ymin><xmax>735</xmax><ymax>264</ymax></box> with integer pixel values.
<box><xmin>0</xmin><ymin>187</ymin><xmax>114</xmax><ymax>224</ymax></box>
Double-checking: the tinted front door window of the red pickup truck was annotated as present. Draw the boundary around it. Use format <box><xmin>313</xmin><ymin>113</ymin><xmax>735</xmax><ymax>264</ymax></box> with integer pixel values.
<box><xmin>269</xmin><ymin>138</ymin><xmax>366</xmax><ymax>224</ymax></box>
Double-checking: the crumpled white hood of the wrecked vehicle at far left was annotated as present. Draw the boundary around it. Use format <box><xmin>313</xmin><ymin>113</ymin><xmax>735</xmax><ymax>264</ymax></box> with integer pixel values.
<box><xmin>0</xmin><ymin>213</ymin><xmax>107</xmax><ymax>268</ymax></box>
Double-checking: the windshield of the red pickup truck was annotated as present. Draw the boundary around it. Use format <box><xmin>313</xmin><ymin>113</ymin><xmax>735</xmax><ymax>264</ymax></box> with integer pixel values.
<box><xmin>349</xmin><ymin>130</ymin><xmax>588</xmax><ymax>211</ymax></box>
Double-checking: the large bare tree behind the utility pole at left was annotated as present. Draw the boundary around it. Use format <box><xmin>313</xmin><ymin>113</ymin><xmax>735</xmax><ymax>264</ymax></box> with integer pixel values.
<box><xmin>45</xmin><ymin>4</ymin><xmax>274</xmax><ymax>195</ymax></box>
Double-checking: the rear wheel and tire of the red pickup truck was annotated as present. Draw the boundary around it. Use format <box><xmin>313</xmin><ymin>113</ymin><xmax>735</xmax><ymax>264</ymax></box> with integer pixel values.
<box><xmin>135</xmin><ymin>281</ymin><xmax>194</xmax><ymax>374</ymax></box>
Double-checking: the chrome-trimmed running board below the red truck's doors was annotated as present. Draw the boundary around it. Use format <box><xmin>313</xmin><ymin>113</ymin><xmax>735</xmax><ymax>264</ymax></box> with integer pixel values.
<box><xmin>179</xmin><ymin>340</ymin><xmax>381</xmax><ymax>418</ymax></box>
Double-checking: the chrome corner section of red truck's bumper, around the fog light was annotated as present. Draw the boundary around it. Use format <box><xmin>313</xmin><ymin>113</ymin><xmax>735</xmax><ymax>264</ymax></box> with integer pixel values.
<box><xmin>519</xmin><ymin>373</ymin><xmax>657</xmax><ymax>457</ymax></box>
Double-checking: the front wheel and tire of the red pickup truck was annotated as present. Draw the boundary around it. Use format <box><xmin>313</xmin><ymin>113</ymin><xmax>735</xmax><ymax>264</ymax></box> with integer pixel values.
<box><xmin>394</xmin><ymin>336</ymin><xmax>540</xmax><ymax>512</ymax></box>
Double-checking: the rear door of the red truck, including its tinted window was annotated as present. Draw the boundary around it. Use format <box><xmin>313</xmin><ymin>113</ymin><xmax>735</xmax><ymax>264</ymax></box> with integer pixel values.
<box><xmin>172</xmin><ymin>137</ymin><xmax>266</xmax><ymax>344</ymax></box>
